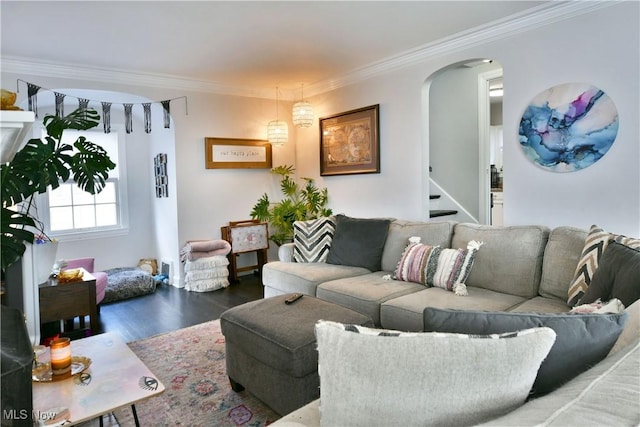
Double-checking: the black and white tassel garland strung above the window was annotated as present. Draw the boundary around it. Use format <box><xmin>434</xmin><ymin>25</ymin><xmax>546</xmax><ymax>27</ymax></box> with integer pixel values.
<box><xmin>17</xmin><ymin>79</ymin><xmax>189</xmax><ymax>133</ymax></box>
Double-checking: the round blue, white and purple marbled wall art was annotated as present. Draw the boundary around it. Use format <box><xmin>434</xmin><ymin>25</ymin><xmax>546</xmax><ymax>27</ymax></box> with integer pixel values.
<box><xmin>519</xmin><ymin>83</ymin><xmax>618</xmax><ymax>172</ymax></box>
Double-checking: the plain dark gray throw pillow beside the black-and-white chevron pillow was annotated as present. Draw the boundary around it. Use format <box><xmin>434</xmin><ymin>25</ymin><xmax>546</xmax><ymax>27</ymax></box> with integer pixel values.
<box><xmin>327</xmin><ymin>215</ymin><xmax>391</xmax><ymax>271</ymax></box>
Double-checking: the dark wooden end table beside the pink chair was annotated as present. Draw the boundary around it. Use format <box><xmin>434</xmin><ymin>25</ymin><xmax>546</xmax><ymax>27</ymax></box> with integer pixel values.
<box><xmin>38</xmin><ymin>268</ymin><xmax>98</xmax><ymax>334</ymax></box>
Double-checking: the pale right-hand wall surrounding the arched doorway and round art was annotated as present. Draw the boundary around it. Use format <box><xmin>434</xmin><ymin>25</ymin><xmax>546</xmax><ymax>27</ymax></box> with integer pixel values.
<box><xmin>297</xmin><ymin>2</ymin><xmax>640</xmax><ymax>236</ymax></box>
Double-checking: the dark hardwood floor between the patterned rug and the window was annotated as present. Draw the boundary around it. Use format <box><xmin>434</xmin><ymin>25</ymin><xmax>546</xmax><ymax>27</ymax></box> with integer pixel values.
<box><xmin>91</xmin><ymin>275</ymin><xmax>263</xmax><ymax>342</ymax></box>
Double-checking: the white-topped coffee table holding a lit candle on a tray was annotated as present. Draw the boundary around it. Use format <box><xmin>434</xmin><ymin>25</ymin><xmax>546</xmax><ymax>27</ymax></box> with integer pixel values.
<box><xmin>33</xmin><ymin>333</ymin><xmax>165</xmax><ymax>425</ymax></box>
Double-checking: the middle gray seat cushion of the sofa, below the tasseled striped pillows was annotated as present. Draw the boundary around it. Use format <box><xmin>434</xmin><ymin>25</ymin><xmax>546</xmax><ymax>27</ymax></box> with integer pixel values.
<box><xmin>316</xmin><ymin>271</ymin><xmax>424</xmax><ymax>325</ymax></box>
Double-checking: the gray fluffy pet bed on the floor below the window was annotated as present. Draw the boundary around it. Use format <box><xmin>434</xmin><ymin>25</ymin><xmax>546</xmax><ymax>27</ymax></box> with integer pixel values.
<box><xmin>102</xmin><ymin>267</ymin><xmax>156</xmax><ymax>303</ymax></box>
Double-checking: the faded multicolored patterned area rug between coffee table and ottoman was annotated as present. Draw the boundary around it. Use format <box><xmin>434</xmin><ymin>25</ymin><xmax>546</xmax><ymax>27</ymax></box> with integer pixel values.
<box><xmin>115</xmin><ymin>320</ymin><xmax>280</xmax><ymax>427</ymax></box>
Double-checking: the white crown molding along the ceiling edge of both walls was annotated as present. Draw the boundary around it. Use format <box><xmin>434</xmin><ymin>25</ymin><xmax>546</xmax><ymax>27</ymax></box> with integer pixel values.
<box><xmin>0</xmin><ymin>0</ymin><xmax>622</xmax><ymax>101</ymax></box>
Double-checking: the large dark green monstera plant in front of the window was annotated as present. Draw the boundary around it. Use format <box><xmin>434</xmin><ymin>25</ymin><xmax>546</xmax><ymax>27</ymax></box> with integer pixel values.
<box><xmin>0</xmin><ymin>109</ymin><xmax>116</xmax><ymax>271</ymax></box>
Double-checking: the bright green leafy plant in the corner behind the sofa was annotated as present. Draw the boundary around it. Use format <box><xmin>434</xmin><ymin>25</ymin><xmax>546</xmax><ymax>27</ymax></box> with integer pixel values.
<box><xmin>251</xmin><ymin>165</ymin><xmax>333</xmax><ymax>245</ymax></box>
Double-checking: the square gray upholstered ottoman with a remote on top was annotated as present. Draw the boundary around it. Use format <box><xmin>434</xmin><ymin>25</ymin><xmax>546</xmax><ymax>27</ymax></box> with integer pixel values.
<box><xmin>220</xmin><ymin>295</ymin><xmax>373</xmax><ymax>415</ymax></box>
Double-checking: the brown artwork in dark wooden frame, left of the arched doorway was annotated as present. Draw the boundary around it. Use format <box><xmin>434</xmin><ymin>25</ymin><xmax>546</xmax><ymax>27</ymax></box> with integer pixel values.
<box><xmin>320</xmin><ymin>104</ymin><xmax>380</xmax><ymax>176</ymax></box>
